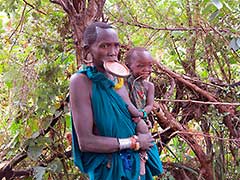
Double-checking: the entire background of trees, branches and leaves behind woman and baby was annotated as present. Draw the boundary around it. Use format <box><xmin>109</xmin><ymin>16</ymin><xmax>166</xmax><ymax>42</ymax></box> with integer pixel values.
<box><xmin>0</xmin><ymin>0</ymin><xmax>240</xmax><ymax>180</ymax></box>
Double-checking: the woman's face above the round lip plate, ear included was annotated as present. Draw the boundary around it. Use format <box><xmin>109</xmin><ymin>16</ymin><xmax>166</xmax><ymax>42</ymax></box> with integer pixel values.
<box><xmin>90</xmin><ymin>28</ymin><xmax>119</xmax><ymax>71</ymax></box>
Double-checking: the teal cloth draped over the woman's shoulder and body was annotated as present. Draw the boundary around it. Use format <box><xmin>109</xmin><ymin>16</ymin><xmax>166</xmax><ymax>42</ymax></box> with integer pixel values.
<box><xmin>72</xmin><ymin>67</ymin><xmax>162</xmax><ymax>180</ymax></box>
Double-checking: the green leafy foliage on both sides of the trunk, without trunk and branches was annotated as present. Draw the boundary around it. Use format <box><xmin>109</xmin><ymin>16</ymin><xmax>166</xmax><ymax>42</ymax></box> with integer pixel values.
<box><xmin>0</xmin><ymin>0</ymin><xmax>240</xmax><ymax>179</ymax></box>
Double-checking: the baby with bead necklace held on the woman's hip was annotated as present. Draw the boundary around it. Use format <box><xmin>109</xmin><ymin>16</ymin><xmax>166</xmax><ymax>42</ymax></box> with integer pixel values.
<box><xmin>117</xmin><ymin>47</ymin><xmax>154</xmax><ymax>175</ymax></box>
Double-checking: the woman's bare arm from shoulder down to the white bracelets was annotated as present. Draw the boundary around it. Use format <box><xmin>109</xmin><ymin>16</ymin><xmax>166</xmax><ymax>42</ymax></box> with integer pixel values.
<box><xmin>70</xmin><ymin>74</ymin><xmax>119</xmax><ymax>153</ymax></box>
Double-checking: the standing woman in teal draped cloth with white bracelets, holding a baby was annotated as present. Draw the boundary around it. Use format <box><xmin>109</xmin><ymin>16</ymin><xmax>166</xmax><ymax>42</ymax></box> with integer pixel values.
<box><xmin>70</xmin><ymin>22</ymin><xmax>162</xmax><ymax>180</ymax></box>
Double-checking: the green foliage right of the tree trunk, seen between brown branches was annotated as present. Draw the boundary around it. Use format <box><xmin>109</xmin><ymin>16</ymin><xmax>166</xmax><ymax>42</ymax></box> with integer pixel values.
<box><xmin>105</xmin><ymin>0</ymin><xmax>240</xmax><ymax>179</ymax></box>
